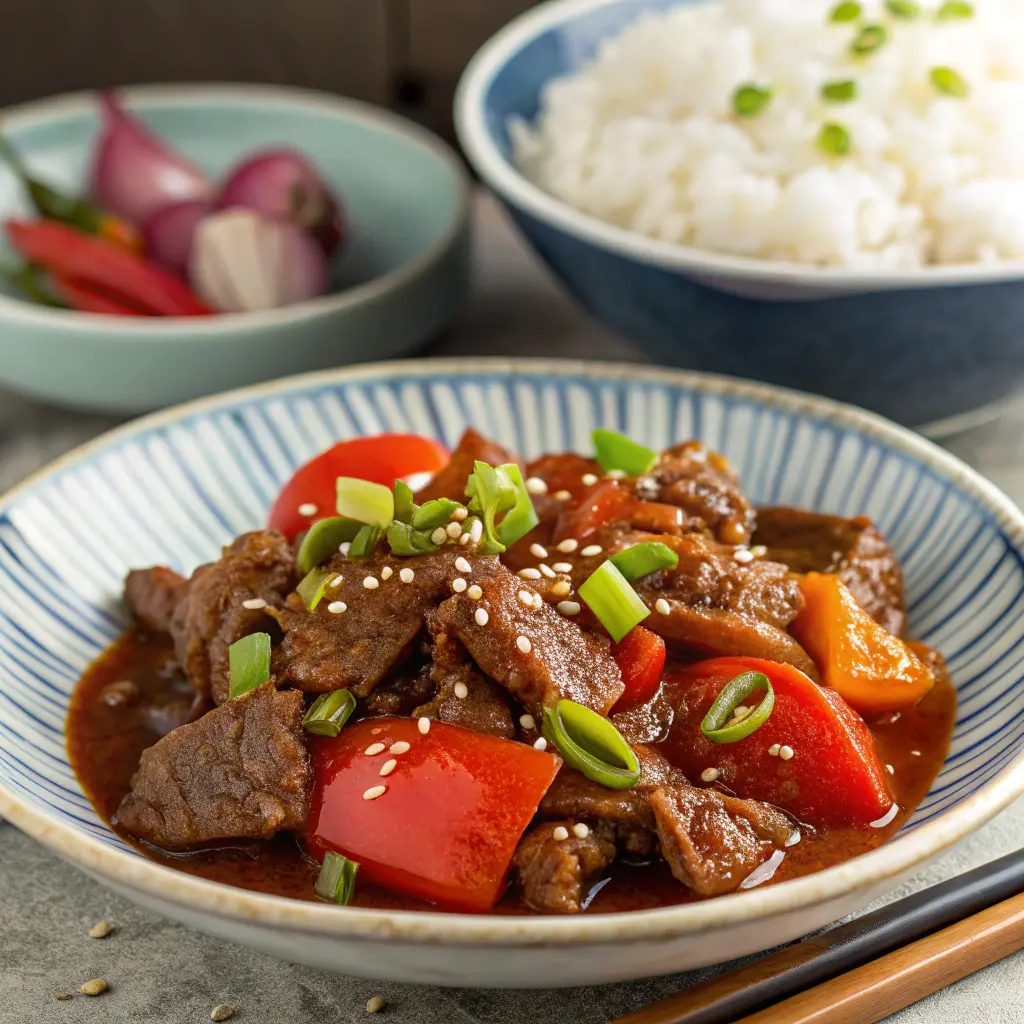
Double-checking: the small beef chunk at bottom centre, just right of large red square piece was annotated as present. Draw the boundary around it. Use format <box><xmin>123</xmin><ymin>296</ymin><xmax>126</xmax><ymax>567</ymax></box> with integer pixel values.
<box><xmin>512</xmin><ymin>821</ymin><xmax>615</xmax><ymax>913</ymax></box>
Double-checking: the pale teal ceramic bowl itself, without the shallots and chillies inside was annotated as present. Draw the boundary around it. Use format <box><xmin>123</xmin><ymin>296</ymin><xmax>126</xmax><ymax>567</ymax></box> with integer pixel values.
<box><xmin>0</xmin><ymin>85</ymin><xmax>469</xmax><ymax>413</ymax></box>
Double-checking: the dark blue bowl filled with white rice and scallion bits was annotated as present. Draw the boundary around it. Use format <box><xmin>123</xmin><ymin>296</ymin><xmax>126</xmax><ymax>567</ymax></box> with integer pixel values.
<box><xmin>456</xmin><ymin>0</ymin><xmax>1024</xmax><ymax>433</ymax></box>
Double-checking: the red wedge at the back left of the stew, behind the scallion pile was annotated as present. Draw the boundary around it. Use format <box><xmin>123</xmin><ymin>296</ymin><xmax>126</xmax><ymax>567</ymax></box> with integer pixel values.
<box><xmin>267</xmin><ymin>434</ymin><xmax>449</xmax><ymax>541</ymax></box>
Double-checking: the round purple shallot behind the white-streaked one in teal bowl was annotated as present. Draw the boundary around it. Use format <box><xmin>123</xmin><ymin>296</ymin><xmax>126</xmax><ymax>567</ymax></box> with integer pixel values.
<box><xmin>217</xmin><ymin>148</ymin><xmax>344</xmax><ymax>255</ymax></box>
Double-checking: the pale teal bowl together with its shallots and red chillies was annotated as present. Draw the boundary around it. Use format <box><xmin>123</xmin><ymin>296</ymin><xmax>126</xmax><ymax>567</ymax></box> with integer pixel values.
<box><xmin>0</xmin><ymin>86</ymin><xmax>468</xmax><ymax>412</ymax></box>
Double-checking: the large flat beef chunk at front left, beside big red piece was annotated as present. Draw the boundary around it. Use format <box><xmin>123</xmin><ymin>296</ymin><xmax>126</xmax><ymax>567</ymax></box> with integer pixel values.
<box><xmin>116</xmin><ymin>683</ymin><xmax>312</xmax><ymax>850</ymax></box>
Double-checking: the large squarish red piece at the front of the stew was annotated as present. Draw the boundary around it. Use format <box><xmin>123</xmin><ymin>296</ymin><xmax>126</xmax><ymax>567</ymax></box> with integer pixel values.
<box><xmin>307</xmin><ymin>718</ymin><xmax>561</xmax><ymax>911</ymax></box>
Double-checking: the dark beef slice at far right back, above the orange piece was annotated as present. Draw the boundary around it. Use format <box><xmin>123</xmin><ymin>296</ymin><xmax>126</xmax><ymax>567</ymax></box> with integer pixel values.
<box><xmin>754</xmin><ymin>508</ymin><xmax>906</xmax><ymax>636</ymax></box>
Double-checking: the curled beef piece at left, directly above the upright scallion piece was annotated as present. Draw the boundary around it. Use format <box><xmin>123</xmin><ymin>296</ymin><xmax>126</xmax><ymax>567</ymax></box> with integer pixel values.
<box><xmin>170</xmin><ymin>530</ymin><xmax>295</xmax><ymax>703</ymax></box>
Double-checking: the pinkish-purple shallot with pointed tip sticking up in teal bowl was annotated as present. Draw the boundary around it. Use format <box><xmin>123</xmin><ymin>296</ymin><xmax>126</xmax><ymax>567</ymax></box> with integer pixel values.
<box><xmin>89</xmin><ymin>92</ymin><xmax>213</xmax><ymax>228</ymax></box>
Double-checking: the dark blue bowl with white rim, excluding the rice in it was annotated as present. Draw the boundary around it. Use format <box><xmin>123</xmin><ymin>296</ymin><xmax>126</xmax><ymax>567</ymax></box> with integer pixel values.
<box><xmin>456</xmin><ymin>0</ymin><xmax>1024</xmax><ymax>434</ymax></box>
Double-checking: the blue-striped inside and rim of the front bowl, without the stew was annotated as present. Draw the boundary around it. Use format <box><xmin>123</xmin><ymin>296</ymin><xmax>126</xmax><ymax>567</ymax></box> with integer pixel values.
<box><xmin>0</xmin><ymin>359</ymin><xmax>1024</xmax><ymax>944</ymax></box>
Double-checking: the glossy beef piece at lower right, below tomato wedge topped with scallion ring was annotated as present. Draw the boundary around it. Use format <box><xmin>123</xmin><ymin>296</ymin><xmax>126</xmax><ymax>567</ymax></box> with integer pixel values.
<box><xmin>648</xmin><ymin>785</ymin><xmax>793</xmax><ymax>896</ymax></box>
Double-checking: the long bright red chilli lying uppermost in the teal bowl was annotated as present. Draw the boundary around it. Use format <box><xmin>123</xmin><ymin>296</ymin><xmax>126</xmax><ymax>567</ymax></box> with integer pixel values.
<box><xmin>7</xmin><ymin>220</ymin><xmax>213</xmax><ymax>316</ymax></box>
